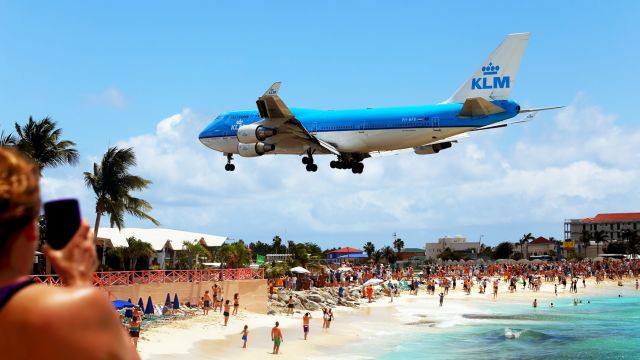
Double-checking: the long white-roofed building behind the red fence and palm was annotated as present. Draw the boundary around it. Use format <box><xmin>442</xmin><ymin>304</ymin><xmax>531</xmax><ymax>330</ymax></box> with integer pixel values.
<box><xmin>95</xmin><ymin>228</ymin><xmax>228</xmax><ymax>269</ymax></box>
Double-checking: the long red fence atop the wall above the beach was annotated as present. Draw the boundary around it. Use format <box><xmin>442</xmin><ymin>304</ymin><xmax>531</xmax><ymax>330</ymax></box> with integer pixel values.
<box><xmin>32</xmin><ymin>268</ymin><xmax>264</xmax><ymax>286</ymax></box>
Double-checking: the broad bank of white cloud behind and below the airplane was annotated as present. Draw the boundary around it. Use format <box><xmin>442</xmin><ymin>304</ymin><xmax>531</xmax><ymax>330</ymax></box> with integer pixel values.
<box><xmin>43</xmin><ymin>94</ymin><xmax>640</xmax><ymax>246</ymax></box>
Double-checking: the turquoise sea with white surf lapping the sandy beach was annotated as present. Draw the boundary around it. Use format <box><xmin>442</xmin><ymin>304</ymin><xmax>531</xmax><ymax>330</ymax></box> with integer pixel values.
<box><xmin>336</xmin><ymin>291</ymin><xmax>640</xmax><ymax>360</ymax></box>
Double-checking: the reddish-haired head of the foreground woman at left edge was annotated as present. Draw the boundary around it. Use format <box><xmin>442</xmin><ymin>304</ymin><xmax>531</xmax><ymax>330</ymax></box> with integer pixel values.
<box><xmin>0</xmin><ymin>147</ymin><xmax>40</xmax><ymax>274</ymax></box>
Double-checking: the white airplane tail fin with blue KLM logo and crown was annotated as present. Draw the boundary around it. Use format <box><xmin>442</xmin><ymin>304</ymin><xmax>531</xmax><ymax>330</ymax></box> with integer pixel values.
<box><xmin>444</xmin><ymin>33</ymin><xmax>531</xmax><ymax>103</ymax></box>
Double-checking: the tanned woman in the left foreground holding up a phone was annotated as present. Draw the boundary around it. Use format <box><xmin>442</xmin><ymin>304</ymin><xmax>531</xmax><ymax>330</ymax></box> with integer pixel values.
<box><xmin>0</xmin><ymin>147</ymin><xmax>139</xmax><ymax>360</ymax></box>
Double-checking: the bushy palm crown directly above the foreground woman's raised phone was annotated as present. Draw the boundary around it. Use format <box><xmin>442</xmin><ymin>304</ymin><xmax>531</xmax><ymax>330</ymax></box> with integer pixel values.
<box><xmin>13</xmin><ymin>117</ymin><xmax>80</xmax><ymax>174</ymax></box>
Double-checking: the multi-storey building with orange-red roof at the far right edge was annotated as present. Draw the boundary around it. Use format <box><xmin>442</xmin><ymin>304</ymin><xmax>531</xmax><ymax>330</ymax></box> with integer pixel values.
<box><xmin>563</xmin><ymin>213</ymin><xmax>640</xmax><ymax>257</ymax></box>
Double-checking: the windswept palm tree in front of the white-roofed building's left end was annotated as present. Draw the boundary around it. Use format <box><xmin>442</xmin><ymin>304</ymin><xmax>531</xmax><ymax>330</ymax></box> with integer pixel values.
<box><xmin>84</xmin><ymin>147</ymin><xmax>160</xmax><ymax>236</ymax></box>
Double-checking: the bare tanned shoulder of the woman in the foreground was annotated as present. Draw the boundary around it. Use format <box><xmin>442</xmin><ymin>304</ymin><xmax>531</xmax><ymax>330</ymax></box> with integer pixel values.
<box><xmin>0</xmin><ymin>285</ymin><xmax>137</xmax><ymax>359</ymax></box>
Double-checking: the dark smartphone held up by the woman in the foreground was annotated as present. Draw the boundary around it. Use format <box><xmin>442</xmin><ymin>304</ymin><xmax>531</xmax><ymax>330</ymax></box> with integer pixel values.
<box><xmin>44</xmin><ymin>199</ymin><xmax>80</xmax><ymax>250</ymax></box>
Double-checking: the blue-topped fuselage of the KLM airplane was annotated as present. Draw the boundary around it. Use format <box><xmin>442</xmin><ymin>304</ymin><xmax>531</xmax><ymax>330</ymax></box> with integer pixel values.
<box><xmin>199</xmin><ymin>100</ymin><xmax>520</xmax><ymax>154</ymax></box>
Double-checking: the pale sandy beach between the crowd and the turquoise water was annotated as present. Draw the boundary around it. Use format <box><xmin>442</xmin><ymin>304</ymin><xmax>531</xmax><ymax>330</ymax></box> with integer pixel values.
<box><xmin>138</xmin><ymin>278</ymin><xmax>640</xmax><ymax>359</ymax></box>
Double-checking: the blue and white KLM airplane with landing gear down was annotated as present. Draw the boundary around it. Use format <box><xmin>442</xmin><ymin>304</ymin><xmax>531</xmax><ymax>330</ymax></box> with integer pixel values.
<box><xmin>199</xmin><ymin>33</ymin><xmax>562</xmax><ymax>174</ymax></box>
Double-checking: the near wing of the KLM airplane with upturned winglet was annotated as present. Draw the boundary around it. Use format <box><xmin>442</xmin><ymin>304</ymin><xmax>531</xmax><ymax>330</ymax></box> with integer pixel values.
<box><xmin>256</xmin><ymin>82</ymin><xmax>340</xmax><ymax>155</ymax></box>
